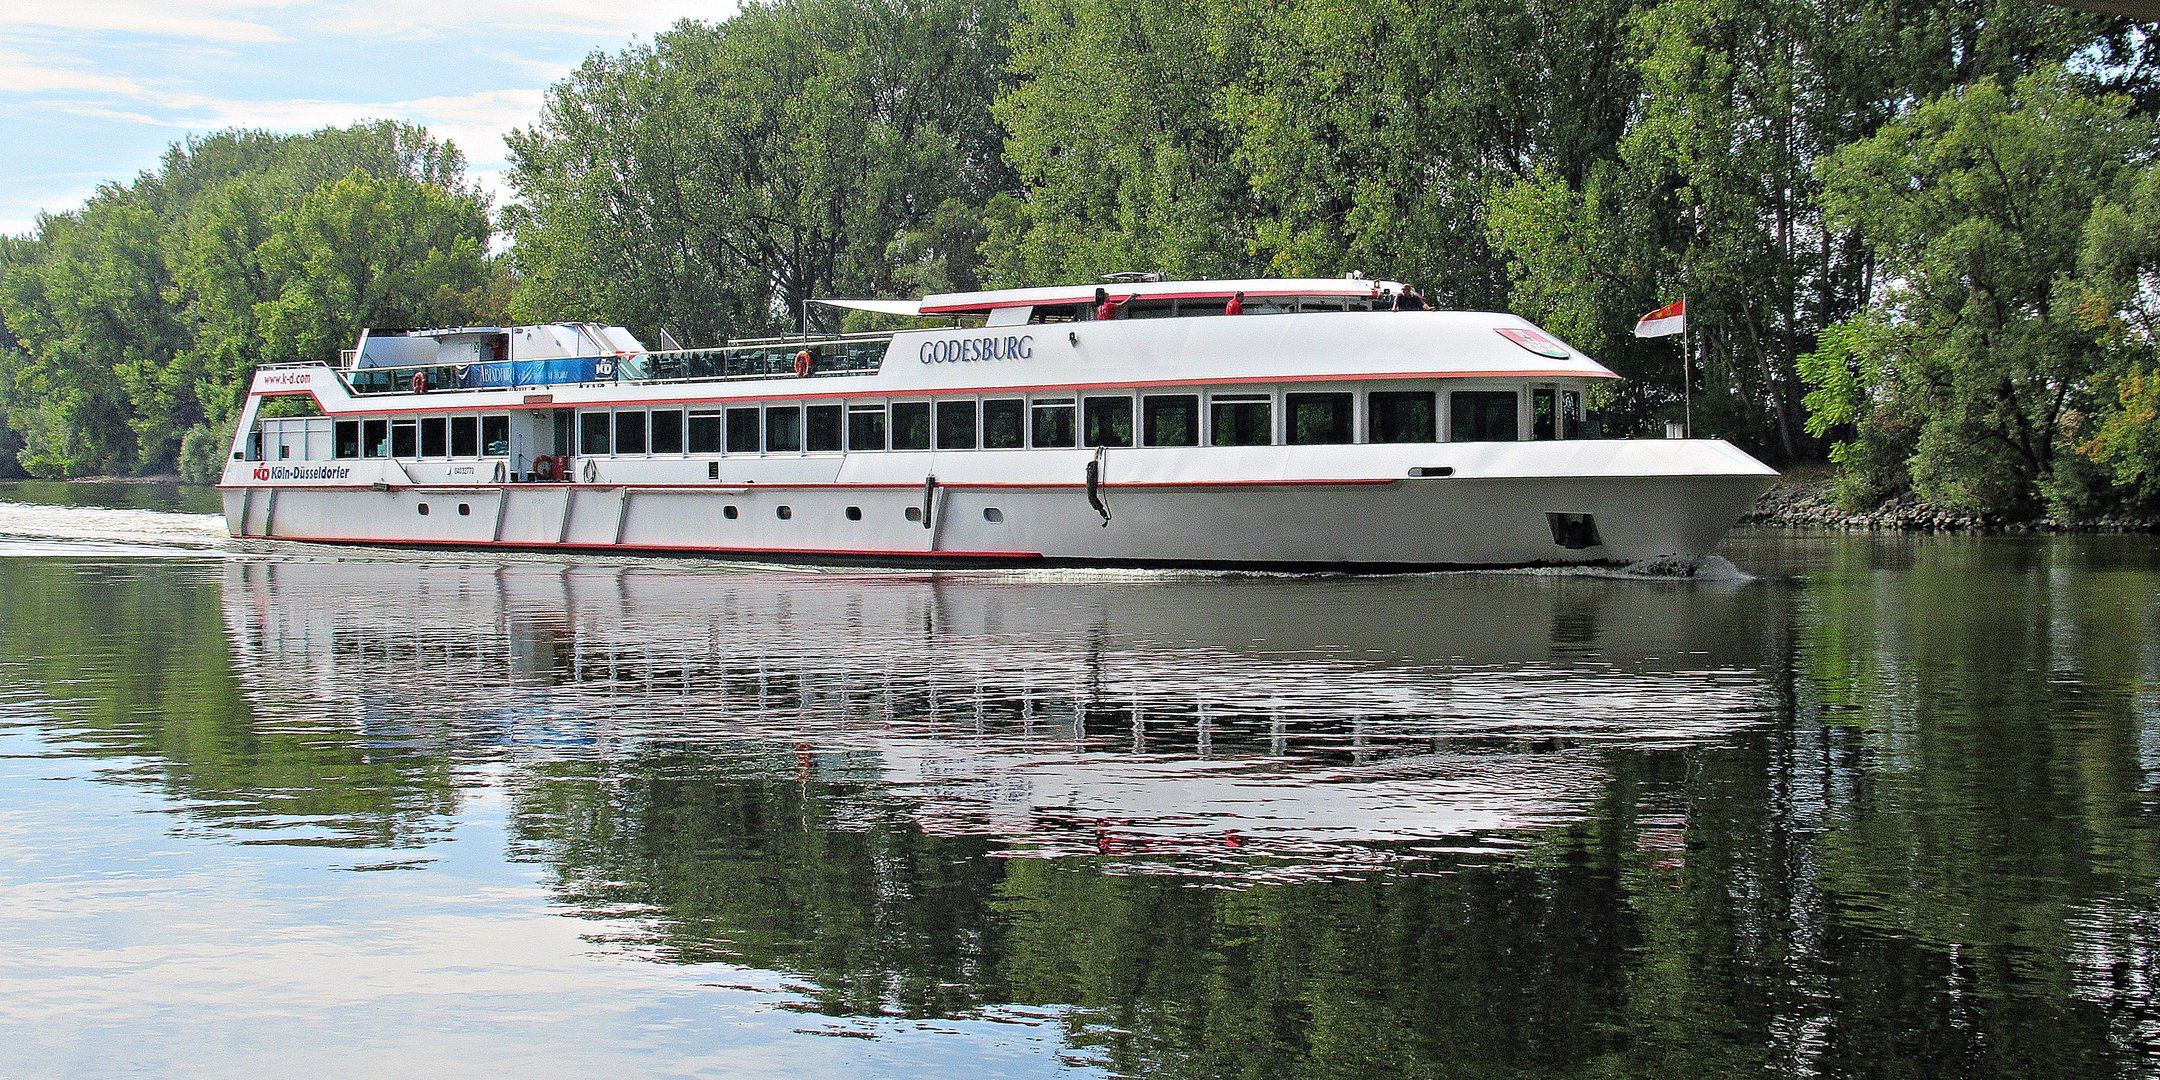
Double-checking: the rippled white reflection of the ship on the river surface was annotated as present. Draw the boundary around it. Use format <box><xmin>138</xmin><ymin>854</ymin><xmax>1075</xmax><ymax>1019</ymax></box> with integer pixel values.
<box><xmin>225</xmin><ymin>562</ymin><xmax>1776</xmax><ymax>858</ymax></box>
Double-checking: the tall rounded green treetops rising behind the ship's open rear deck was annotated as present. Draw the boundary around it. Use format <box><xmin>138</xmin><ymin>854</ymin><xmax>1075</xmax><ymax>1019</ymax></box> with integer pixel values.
<box><xmin>505</xmin><ymin>0</ymin><xmax>1009</xmax><ymax>341</ymax></box>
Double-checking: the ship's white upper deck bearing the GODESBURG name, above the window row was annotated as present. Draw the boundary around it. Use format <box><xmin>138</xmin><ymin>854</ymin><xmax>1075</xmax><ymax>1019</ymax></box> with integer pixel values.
<box><xmin>255</xmin><ymin>279</ymin><xmax>1618</xmax><ymax>413</ymax></box>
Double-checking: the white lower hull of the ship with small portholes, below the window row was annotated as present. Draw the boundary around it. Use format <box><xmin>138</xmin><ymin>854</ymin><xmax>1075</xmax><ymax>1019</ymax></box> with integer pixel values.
<box><xmin>225</xmin><ymin>441</ymin><xmax>1773</xmax><ymax>570</ymax></box>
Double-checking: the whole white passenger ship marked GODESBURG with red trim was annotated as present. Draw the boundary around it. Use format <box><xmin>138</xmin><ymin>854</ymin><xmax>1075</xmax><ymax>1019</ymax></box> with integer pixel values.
<box><xmin>220</xmin><ymin>276</ymin><xmax>1776</xmax><ymax>570</ymax></box>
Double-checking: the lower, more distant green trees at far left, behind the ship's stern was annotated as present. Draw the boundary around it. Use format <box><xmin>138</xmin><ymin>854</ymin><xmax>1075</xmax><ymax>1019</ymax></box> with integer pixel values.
<box><xmin>0</xmin><ymin>121</ymin><xmax>501</xmax><ymax>475</ymax></box>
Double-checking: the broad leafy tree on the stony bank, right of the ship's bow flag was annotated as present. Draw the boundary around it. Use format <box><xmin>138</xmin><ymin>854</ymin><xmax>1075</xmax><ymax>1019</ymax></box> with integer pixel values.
<box><xmin>1821</xmin><ymin>67</ymin><xmax>2154</xmax><ymax>512</ymax></box>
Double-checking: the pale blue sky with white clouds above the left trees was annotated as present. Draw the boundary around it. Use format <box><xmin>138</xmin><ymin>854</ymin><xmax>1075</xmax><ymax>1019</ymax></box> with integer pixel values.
<box><xmin>0</xmin><ymin>0</ymin><xmax>737</xmax><ymax>235</ymax></box>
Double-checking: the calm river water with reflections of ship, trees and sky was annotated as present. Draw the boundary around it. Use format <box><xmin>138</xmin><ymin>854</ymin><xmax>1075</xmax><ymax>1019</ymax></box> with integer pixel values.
<box><xmin>0</xmin><ymin>484</ymin><xmax>2160</xmax><ymax>1080</ymax></box>
